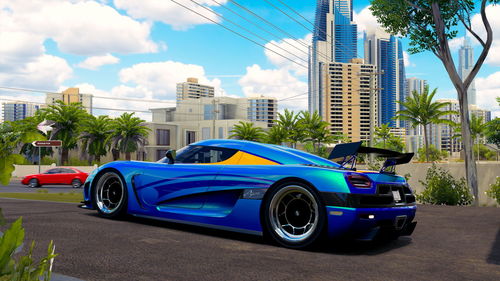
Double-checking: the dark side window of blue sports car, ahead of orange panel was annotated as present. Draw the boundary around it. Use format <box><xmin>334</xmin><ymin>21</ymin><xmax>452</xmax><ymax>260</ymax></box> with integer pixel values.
<box><xmin>176</xmin><ymin>146</ymin><xmax>238</xmax><ymax>164</ymax></box>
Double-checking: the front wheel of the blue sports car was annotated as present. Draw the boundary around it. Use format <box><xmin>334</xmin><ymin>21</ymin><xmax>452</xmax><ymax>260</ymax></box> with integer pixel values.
<box><xmin>92</xmin><ymin>171</ymin><xmax>128</xmax><ymax>219</ymax></box>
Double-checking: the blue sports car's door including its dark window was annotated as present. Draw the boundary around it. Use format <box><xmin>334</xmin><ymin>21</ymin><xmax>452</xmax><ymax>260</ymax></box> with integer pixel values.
<box><xmin>134</xmin><ymin>146</ymin><xmax>237</xmax><ymax>211</ymax></box>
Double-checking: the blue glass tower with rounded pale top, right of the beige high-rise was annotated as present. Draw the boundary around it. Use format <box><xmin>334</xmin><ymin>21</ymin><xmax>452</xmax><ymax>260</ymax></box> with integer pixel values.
<box><xmin>364</xmin><ymin>27</ymin><xmax>406</xmax><ymax>127</ymax></box>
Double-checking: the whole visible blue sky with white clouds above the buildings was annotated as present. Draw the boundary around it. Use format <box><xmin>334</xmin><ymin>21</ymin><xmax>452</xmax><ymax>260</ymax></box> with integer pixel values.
<box><xmin>0</xmin><ymin>0</ymin><xmax>500</xmax><ymax>119</ymax></box>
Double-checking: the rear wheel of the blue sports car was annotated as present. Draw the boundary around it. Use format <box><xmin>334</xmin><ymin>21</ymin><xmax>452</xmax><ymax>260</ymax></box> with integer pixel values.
<box><xmin>262</xmin><ymin>182</ymin><xmax>326</xmax><ymax>249</ymax></box>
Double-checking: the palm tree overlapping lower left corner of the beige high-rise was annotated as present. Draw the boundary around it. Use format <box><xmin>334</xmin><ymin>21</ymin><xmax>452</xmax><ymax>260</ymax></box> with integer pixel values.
<box><xmin>299</xmin><ymin>111</ymin><xmax>338</xmax><ymax>151</ymax></box>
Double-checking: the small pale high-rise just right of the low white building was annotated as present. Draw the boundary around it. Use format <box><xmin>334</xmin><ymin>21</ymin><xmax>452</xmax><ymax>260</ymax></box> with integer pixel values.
<box><xmin>248</xmin><ymin>96</ymin><xmax>278</xmax><ymax>127</ymax></box>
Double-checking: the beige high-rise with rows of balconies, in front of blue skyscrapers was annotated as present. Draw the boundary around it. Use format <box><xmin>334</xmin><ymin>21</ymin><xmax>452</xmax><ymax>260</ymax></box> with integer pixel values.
<box><xmin>322</xmin><ymin>59</ymin><xmax>378</xmax><ymax>141</ymax></box>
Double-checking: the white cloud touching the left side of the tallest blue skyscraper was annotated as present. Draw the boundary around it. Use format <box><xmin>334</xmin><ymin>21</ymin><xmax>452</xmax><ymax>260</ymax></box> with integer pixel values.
<box><xmin>238</xmin><ymin>64</ymin><xmax>307</xmax><ymax>110</ymax></box>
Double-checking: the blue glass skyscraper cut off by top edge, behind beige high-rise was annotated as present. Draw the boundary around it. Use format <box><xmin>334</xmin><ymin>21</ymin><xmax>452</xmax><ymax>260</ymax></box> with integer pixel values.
<box><xmin>308</xmin><ymin>0</ymin><xmax>357</xmax><ymax>115</ymax></box>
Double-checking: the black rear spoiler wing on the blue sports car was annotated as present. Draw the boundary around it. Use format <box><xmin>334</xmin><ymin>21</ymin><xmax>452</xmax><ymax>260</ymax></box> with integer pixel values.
<box><xmin>328</xmin><ymin>141</ymin><xmax>414</xmax><ymax>173</ymax></box>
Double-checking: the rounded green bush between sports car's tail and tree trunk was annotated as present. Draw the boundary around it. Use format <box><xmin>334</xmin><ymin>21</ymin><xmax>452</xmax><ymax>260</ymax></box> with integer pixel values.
<box><xmin>416</xmin><ymin>164</ymin><xmax>473</xmax><ymax>205</ymax></box>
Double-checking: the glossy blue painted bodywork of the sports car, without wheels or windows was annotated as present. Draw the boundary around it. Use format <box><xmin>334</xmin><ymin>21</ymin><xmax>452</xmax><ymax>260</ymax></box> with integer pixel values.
<box><xmin>84</xmin><ymin>140</ymin><xmax>416</xmax><ymax>237</ymax></box>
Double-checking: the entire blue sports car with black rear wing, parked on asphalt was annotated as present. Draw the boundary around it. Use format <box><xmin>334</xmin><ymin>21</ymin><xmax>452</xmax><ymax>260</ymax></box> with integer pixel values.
<box><xmin>82</xmin><ymin>140</ymin><xmax>417</xmax><ymax>248</ymax></box>
